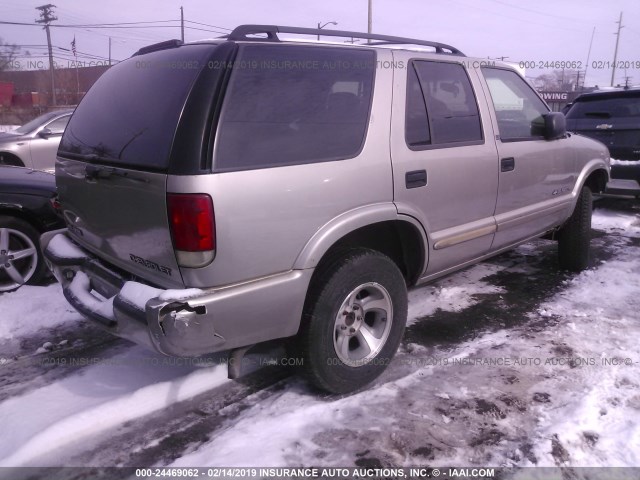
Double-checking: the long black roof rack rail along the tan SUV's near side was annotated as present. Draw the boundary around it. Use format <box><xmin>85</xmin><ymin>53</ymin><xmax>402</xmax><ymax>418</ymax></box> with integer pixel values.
<box><xmin>227</xmin><ymin>25</ymin><xmax>465</xmax><ymax>57</ymax></box>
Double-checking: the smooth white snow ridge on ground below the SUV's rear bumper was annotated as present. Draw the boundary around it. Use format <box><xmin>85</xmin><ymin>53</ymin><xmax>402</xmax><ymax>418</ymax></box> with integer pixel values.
<box><xmin>0</xmin><ymin>347</ymin><xmax>227</xmax><ymax>467</ymax></box>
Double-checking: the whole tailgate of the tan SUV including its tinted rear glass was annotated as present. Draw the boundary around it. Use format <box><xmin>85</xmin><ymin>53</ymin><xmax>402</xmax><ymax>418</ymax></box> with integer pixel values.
<box><xmin>56</xmin><ymin>44</ymin><xmax>217</xmax><ymax>288</ymax></box>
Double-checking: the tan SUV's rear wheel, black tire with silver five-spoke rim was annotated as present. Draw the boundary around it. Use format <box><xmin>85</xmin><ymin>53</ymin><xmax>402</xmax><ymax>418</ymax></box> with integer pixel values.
<box><xmin>294</xmin><ymin>249</ymin><xmax>408</xmax><ymax>394</ymax></box>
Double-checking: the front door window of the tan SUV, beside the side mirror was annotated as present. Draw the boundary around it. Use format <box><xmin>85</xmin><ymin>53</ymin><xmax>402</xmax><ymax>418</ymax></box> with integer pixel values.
<box><xmin>482</xmin><ymin>67</ymin><xmax>549</xmax><ymax>142</ymax></box>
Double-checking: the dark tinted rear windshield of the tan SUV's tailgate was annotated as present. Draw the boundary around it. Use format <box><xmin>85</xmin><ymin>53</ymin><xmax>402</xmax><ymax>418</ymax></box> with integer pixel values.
<box><xmin>59</xmin><ymin>45</ymin><xmax>212</xmax><ymax>171</ymax></box>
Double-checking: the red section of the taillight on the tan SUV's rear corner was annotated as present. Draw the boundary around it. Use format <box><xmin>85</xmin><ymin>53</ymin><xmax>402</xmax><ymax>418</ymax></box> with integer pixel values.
<box><xmin>167</xmin><ymin>193</ymin><xmax>216</xmax><ymax>252</ymax></box>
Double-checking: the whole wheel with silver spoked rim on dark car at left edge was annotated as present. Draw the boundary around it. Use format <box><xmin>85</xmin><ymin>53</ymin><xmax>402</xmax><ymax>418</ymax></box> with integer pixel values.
<box><xmin>0</xmin><ymin>216</ymin><xmax>46</xmax><ymax>292</ymax></box>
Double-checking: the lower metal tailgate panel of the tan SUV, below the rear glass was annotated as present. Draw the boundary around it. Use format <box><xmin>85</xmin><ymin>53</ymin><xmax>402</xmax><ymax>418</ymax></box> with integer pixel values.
<box><xmin>56</xmin><ymin>159</ymin><xmax>183</xmax><ymax>288</ymax></box>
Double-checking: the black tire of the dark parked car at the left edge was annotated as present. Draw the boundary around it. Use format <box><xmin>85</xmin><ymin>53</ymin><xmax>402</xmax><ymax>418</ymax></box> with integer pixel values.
<box><xmin>0</xmin><ymin>215</ymin><xmax>47</xmax><ymax>292</ymax></box>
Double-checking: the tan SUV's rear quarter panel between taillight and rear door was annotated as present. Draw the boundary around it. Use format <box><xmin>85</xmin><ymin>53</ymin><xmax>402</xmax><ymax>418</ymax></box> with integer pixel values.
<box><xmin>172</xmin><ymin>50</ymin><xmax>393</xmax><ymax>287</ymax></box>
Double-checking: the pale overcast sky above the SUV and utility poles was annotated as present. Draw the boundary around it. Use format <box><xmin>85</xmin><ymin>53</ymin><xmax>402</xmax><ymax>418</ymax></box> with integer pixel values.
<box><xmin>0</xmin><ymin>0</ymin><xmax>640</xmax><ymax>86</ymax></box>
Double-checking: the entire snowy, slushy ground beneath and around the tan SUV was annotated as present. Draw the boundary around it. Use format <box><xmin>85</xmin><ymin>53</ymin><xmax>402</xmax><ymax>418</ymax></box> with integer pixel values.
<box><xmin>0</xmin><ymin>199</ymin><xmax>640</xmax><ymax>478</ymax></box>
